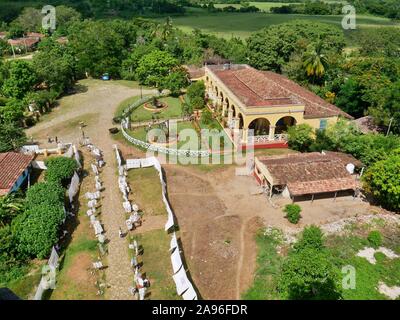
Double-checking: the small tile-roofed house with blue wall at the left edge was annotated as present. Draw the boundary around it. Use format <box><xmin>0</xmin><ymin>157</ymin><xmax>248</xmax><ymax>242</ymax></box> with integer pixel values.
<box><xmin>0</xmin><ymin>152</ymin><xmax>35</xmax><ymax>197</ymax></box>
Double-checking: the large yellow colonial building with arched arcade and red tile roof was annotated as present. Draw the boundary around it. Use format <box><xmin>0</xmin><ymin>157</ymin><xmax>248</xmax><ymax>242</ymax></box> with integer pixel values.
<box><xmin>203</xmin><ymin>64</ymin><xmax>351</xmax><ymax>148</ymax></box>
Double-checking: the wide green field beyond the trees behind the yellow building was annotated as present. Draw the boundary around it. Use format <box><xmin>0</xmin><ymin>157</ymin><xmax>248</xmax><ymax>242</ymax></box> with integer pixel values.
<box><xmin>167</xmin><ymin>11</ymin><xmax>400</xmax><ymax>39</ymax></box>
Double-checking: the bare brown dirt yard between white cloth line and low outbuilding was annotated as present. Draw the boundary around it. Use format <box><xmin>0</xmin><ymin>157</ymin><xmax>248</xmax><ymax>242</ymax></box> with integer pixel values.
<box><xmin>164</xmin><ymin>165</ymin><xmax>371</xmax><ymax>299</ymax></box>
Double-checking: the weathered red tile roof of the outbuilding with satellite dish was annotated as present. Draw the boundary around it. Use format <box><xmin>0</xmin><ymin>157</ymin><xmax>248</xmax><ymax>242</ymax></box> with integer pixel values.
<box><xmin>259</xmin><ymin>152</ymin><xmax>359</xmax><ymax>196</ymax></box>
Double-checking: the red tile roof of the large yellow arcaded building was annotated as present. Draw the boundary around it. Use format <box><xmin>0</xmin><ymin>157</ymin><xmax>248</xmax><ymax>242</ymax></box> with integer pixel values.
<box><xmin>209</xmin><ymin>65</ymin><xmax>352</xmax><ymax>118</ymax></box>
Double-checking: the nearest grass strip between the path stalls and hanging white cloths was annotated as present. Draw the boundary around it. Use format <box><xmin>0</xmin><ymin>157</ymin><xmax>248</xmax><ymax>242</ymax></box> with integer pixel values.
<box><xmin>131</xmin><ymin>230</ymin><xmax>182</xmax><ymax>300</ymax></box>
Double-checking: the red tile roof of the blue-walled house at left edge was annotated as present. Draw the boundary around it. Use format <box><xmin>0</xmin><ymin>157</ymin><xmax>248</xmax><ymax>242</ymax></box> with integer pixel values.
<box><xmin>0</xmin><ymin>152</ymin><xmax>34</xmax><ymax>196</ymax></box>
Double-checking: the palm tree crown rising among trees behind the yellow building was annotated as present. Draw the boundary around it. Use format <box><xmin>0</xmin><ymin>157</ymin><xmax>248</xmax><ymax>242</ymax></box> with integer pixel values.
<box><xmin>303</xmin><ymin>41</ymin><xmax>328</xmax><ymax>79</ymax></box>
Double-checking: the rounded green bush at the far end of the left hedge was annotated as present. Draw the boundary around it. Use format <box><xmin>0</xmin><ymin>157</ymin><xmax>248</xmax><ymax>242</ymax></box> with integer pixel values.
<box><xmin>45</xmin><ymin>157</ymin><xmax>78</xmax><ymax>184</ymax></box>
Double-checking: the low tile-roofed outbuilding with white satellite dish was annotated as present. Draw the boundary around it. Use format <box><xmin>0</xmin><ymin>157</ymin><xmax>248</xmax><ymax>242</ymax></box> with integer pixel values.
<box><xmin>254</xmin><ymin>152</ymin><xmax>362</xmax><ymax>201</ymax></box>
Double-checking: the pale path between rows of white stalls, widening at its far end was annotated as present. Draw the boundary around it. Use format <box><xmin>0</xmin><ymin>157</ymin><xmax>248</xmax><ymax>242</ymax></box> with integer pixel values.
<box><xmin>27</xmin><ymin>83</ymin><xmax>156</xmax><ymax>300</ymax></box>
